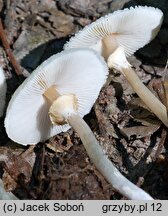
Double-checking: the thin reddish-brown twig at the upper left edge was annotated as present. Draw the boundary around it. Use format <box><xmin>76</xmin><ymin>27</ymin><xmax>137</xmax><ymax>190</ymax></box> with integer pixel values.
<box><xmin>0</xmin><ymin>18</ymin><xmax>22</xmax><ymax>75</ymax></box>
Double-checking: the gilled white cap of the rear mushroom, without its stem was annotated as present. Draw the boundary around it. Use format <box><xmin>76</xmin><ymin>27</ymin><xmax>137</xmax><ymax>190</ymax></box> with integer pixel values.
<box><xmin>64</xmin><ymin>6</ymin><xmax>163</xmax><ymax>56</ymax></box>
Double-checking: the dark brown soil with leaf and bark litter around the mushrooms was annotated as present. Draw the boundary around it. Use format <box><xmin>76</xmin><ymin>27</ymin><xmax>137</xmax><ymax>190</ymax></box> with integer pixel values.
<box><xmin>0</xmin><ymin>0</ymin><xmax>168</xmax><ymax>200</ymax></box>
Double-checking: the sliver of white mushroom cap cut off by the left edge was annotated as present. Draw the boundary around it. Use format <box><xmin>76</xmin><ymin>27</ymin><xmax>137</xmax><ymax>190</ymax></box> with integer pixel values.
<box><xmin>0</xmin><ymin>67</ymin><xmax>7</xmax><ymax>117</ymax></box>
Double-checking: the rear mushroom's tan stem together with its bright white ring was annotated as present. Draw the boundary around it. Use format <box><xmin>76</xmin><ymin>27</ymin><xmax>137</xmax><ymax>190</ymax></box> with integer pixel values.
<box><xmin>107</xmin><ymin>47</ymin><xmax>168</xmax><ymax>127</ymax></box>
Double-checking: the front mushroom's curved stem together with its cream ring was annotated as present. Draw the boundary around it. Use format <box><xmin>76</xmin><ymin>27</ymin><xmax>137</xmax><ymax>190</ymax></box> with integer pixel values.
<box><xmin>46</xmin><ymin>94</ymin><xmax>152</xmax><ymax>200</ymax></box>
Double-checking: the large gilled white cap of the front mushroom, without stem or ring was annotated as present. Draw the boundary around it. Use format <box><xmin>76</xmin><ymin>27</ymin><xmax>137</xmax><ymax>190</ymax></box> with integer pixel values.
<box><xmin>5</xmin><ymin>49</ymin><xmax>108</xmax><ymax>145</ymax></box>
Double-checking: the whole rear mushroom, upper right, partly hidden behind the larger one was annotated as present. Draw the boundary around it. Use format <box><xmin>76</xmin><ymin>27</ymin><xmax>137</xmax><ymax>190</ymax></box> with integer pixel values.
<box><xmin>64</xmin><ymin>6</ymin><xmax>168</xmax><ymax>126</ymax></box>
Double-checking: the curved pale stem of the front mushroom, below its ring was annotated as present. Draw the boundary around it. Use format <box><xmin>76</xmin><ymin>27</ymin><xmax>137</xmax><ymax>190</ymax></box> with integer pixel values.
<box><xmin>68</xmin><ymin>114</ymin><xmax>152</xmax><ymax>200</ymax></box>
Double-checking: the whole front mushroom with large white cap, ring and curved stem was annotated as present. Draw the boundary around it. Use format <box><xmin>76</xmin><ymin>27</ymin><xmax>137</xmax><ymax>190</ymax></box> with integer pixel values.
<box><xmin>5</xmin><ymin>49</ymin><xmax>152</xmax><ymax>200</ymax></box>
